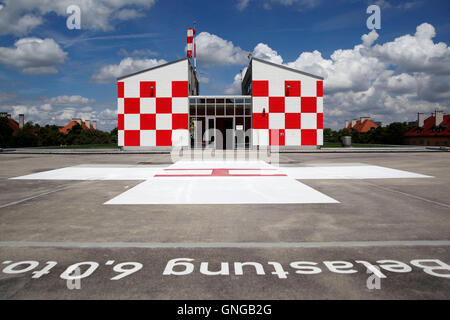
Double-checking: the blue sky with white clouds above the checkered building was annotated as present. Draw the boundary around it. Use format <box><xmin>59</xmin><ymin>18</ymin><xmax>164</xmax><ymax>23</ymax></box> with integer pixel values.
<box><xmin>0</xmin><ymin>0</ymin><xmax>450</xmax><ymax>130</ymax></box>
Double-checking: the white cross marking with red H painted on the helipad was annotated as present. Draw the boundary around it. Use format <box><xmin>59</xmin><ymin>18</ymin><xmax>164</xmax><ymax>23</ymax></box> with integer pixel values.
<box><xmin>12</xmin><ymin>161</ymin><xmax>432</xmax><ymax>205</ymax></box>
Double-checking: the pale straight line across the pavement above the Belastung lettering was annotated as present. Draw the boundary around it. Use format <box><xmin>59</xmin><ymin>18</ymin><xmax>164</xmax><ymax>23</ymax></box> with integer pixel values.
<box><xmin>0</xmin><ymin>240</ymin><xmax>450</xmax><ymax>249</ymax></box>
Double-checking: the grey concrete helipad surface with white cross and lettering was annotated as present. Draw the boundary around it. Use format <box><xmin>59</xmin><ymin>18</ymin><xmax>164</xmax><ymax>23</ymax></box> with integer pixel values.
<box><xmin>0</xmin><ymin>153</ymin><xmax>450</xmax><ymax>299</ymax></box>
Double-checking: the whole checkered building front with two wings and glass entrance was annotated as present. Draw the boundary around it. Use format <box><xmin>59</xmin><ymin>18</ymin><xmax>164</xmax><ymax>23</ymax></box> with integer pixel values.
<box><xmin>117</xmin><ymin>58</ymin><xmax>323</xmax><ymax>150</ymax></box>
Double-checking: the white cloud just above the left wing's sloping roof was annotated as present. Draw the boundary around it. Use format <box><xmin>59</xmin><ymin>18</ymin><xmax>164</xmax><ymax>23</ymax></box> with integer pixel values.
<box><xmin>91</xmin><ymin>57</ymin><xmax>167</xmax><ymax>83</ymax></box>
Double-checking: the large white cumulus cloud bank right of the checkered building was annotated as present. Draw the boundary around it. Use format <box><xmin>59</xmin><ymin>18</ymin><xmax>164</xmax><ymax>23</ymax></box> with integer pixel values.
<box><xmin>224</xmin><ymin>23</ymin><xmax>450</xmax><ymax>129</ymax></box>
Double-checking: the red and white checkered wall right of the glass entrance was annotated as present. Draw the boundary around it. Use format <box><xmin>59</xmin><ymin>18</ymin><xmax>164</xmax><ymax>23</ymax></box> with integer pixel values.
<box><xmin>252</xmin><ymin>62</ymin><xmax>323</xmax><ymax>146</ymax></box>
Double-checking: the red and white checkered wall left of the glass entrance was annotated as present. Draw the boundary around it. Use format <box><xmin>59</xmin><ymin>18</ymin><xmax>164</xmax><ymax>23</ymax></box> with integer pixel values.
<box><xmin>117</xmin><ymin>80</ymin><xmax>189</xmax><ymax>147</ymax></box>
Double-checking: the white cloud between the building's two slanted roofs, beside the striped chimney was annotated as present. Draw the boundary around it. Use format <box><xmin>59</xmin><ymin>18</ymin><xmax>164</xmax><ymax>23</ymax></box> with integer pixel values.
<box><xmin>195</xmin><ymin>32</ymin><xmax>248</xmax><ymax>67</ymax></box>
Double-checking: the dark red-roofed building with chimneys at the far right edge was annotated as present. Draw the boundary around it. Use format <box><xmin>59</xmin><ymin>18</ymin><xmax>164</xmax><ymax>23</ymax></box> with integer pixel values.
<box><xmin>404</xmin><ymin>110</ymin><xmax>450</xmax><ymax>146</ymax></box>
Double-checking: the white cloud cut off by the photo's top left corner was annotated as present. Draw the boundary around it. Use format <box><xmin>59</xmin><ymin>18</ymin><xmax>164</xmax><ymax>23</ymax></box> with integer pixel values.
<box><xmin>0</xmin><ymin>0</ymin><xmax>155</xmax><ymax>35</ymax></box>
